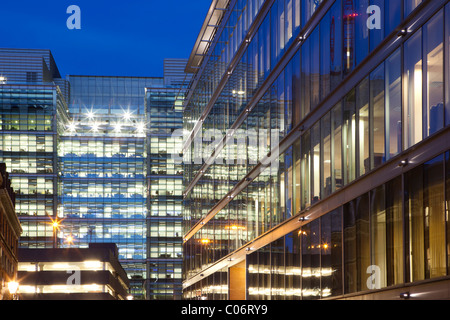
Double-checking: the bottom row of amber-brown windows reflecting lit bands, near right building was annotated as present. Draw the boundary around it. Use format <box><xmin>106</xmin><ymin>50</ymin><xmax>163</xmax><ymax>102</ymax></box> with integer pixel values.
<box><xmin>186</xmin><ymin>148</ymin><xmax>450</xmax><ymax>300</ymax></box>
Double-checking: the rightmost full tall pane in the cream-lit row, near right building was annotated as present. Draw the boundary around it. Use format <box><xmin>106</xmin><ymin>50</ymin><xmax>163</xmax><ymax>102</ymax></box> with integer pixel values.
<box><xmin>423</xmin><ymin>12</ymin><xmax>444</xmax><ymax>136</ymax></box>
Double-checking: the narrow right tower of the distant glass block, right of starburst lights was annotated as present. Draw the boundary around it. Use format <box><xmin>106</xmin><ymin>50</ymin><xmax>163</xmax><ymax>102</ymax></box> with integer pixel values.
<box><xmin>146</xmin><ymin>86</ymin><xmax>186</xmax><ymax>300</ymax></box>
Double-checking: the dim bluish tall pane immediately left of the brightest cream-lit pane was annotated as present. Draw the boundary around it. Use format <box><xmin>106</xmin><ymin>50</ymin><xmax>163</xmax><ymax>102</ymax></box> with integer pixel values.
<box><xmin>385</xmin><ymin>49</ymin><xmax>402</xmax><ymax>160</ymax></box>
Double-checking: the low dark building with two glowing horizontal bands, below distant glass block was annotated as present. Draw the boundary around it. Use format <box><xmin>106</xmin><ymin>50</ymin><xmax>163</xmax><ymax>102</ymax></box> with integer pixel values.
<box><xmin>18</xmin><ymin>243</ymin><xmax>130</xmax><ymax>300</ymax></box>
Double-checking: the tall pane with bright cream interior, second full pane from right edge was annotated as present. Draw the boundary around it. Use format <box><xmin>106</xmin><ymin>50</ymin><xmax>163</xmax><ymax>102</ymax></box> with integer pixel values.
<box><xmin>403</xmin><ymin>30</ymin><xmax>422</xmax><ymax>149</ymax></box>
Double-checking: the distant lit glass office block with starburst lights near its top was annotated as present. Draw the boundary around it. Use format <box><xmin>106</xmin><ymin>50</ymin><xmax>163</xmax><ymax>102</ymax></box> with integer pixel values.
<box><xmin>0</xmin><ymin>49</ymin><xmax>189</xmax><ymax>299</ymax></box>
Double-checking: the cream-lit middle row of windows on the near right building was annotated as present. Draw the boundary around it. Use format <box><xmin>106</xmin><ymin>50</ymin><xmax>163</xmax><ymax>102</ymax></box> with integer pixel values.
<box><xmin>185</xmin><ymin>5</ymin><xmax>450</xmax><ymax>242</ymax></box>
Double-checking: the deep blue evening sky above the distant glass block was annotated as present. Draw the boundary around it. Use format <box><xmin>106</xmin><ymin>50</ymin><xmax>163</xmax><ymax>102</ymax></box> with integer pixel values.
<box><xmin>0</xmin><ymin>0</ymin><xmax>211</xmax><ymax>77</ymax></box>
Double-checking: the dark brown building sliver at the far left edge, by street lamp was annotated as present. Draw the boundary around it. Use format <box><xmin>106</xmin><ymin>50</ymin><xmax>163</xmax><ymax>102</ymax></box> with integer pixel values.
<box><xmin>0</xmin><ymin>163</ymin><xmax>22</xmax><ymax>300</ymax></box>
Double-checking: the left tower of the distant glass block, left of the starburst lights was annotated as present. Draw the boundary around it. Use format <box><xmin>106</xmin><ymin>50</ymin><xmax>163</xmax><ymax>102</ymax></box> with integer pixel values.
<box><xmin>0</xmin><ymin>49</ymin><xmax>69</xmax><ymax>248</ymax></box>
